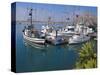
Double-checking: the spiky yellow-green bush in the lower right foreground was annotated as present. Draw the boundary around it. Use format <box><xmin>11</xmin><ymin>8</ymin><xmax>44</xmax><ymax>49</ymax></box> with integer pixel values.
<box><xmin>75</xmin><ymin>42</ymin><xmax>97</xmax><ymax>69</ymax></box>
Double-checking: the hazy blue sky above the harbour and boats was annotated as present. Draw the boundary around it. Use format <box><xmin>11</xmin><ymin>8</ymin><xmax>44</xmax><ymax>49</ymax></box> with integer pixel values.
<box><xmin>16</xmin><ymin>2</ymin><xmax>97</xmax><ymax>22</ymax></box>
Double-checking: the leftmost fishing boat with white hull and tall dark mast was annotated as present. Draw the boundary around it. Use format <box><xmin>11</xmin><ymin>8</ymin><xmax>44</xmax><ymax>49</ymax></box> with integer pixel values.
<box><xmin>23</xmin><ymin>9</ymin><xmax>45</xmax><ymax>44</ymax></box>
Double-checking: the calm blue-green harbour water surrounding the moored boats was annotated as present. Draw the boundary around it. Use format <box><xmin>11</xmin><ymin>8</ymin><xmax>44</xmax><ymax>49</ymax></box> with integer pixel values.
<box><xmin>16</xmin><ymin>24</ymin><xmax>94</xmax><ymax>72</ymax></box>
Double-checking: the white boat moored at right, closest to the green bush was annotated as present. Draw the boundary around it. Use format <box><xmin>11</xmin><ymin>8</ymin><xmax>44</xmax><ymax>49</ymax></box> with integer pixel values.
<box><xmin>68</xmin><ymin>22</ymin><xmax>90</xmax><ymax>44</ymax></box>
